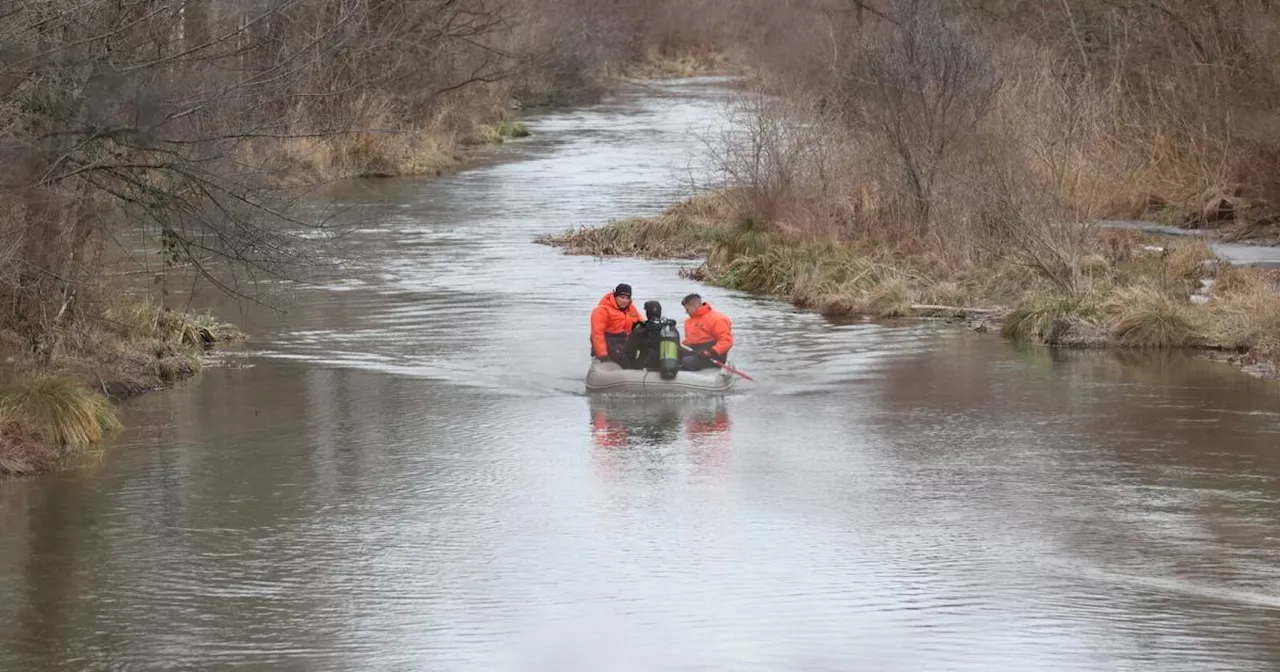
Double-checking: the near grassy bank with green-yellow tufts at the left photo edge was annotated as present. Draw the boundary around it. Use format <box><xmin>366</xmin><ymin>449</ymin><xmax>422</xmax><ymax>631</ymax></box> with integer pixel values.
<box><xmin>0</xmin><ymin>300</ymin><xmax>243</xmax><ymax>477</ymax></box>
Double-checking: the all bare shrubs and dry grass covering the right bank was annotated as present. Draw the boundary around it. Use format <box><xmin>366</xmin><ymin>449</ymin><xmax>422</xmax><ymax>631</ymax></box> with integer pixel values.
<box><xmin>542</xmin><ymin>0</ymin><xmax>1280</xmax><ymax>366</ymax></box>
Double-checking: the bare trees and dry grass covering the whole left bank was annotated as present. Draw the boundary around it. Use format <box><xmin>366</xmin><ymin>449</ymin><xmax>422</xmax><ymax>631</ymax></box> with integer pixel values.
<box><xmin>0</xmin><ymin>0</ymin><xmax>742</xmax><ymax>474</ymax></box>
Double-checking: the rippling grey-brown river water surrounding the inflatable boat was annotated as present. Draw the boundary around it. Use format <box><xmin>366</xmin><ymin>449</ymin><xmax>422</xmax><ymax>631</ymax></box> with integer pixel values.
<box><xmin>0</xmin><ymin>77</ymin><xmax>1280</xmax><ymax>671</ymax></box>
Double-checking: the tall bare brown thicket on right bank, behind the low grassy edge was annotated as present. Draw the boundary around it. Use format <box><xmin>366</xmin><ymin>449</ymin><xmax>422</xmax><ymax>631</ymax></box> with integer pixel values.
<box><xmin>660</xmin><ymin>0</ymin><xmax>1280</xmax><ymax>306</ymax></box>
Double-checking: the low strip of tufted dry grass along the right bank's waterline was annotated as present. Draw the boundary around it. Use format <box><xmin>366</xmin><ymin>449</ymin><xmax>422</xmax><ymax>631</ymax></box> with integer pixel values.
<box><xmin>536</xmin><ymin>192</ymin><xmax>1280</xmax><ymax>370</ymax></box>
